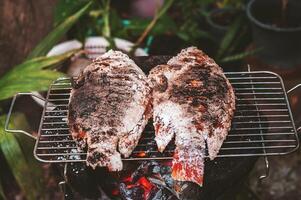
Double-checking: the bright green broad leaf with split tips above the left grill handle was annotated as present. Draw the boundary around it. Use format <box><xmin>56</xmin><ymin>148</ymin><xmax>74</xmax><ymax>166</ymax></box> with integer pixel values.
<box><xmin>0</xmin><ymin>51</ymin><xmax>75</xmax><ymax>100</ymax></box>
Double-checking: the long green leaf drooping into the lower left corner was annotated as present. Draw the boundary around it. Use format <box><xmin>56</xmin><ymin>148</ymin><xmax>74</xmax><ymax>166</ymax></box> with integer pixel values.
<box><xmin>0</xmin><ymin>113</ymin><xmax>44</xmax><ymax>200</ymax></box>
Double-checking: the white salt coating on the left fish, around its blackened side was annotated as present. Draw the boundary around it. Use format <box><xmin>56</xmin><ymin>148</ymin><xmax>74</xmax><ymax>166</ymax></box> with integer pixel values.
<box><xmin>71</xmin><ymin>50</ymin><xmax>151</xmax><ymax>171</ymax></box>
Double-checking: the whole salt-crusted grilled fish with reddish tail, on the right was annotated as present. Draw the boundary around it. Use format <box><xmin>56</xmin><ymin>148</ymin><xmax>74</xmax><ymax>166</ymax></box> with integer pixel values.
<box><xmin>149</xmin><ymin>47</ymin><xmax>235</xmax><ymax>185</ymax></box>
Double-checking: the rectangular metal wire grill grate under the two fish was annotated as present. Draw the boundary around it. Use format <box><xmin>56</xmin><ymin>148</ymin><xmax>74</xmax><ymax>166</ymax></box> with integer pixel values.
<box><xmin>34</xmin><ymin>72</ymin><xmax>299</xmax><ymax>162</ymax></box>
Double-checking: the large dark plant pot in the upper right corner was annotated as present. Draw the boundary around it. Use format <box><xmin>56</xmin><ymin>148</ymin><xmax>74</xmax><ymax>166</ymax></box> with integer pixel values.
<box><xmin>247</xmin><ymin>0</ymin><xmax>301</xmax><ymax>68</ymax></box>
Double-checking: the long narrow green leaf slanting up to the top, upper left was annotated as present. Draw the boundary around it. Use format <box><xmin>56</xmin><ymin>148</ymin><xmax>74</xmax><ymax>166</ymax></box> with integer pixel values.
<box><xmin>27</xmin><ymin>2</ymin><xmax>92</xmax><ymax>59</ymax></box>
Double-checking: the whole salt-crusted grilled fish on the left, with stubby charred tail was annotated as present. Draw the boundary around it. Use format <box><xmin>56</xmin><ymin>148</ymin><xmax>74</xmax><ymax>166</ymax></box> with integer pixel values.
<box><xmin>68</xmin><ymin>50</ymin><xmax>151</xmax><ymax>171</ymax></box>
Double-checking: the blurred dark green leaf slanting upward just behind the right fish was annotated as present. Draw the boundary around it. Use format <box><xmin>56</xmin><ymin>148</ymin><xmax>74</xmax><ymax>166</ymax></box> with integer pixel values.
<box><xmin>216</xmin><ymin>17</ymin><xmax>243</xmax><ymax>60</ymax></box>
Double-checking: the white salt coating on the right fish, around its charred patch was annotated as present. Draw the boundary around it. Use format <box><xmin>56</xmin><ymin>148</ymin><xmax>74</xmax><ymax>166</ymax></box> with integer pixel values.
<box><xmin>149</xmin><ymin>47</ymin><xmax>235</xmax><ymax>185</ymax></box>
